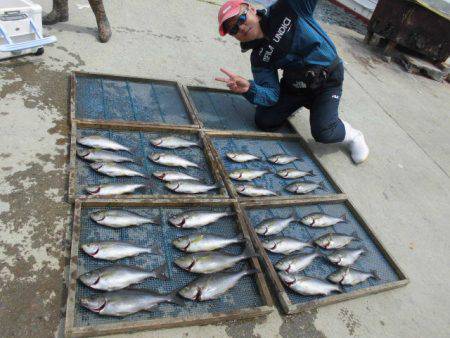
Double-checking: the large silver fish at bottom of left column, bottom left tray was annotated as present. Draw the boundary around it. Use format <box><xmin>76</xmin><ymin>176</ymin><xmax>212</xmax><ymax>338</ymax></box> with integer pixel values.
<box><xmin>80</xmin><ymin>289</ymin><xmax>184</xmax><ymax>317</ymax></box>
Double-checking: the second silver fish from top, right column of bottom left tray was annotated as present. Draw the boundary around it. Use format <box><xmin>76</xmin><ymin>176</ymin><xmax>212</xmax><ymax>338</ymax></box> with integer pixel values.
<box><xmin>172</xmin><ymin>234</ymin><xmax>246</xmax><ymax>252</ymax></box>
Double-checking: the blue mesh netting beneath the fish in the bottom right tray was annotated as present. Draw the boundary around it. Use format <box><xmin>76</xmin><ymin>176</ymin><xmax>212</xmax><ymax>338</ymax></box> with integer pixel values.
<box><xmin>247</xmin><ymin>203</ymin><xmax>399</xmax><ymax>304</ymax></box>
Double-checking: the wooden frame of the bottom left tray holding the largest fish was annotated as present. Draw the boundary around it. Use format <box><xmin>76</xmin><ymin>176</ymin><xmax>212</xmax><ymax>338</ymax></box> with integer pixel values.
<box><xmin>65</xmin><ymin>199</ymin><xmax>273</xmax><ymax>337</ymax></box>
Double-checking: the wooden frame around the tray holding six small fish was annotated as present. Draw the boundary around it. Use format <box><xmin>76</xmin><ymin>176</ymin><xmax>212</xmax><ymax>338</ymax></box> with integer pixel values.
<box><xmin>205</xmin><ymin>130</ymin><xmax>346</xmax><ymax>203</ymax></box>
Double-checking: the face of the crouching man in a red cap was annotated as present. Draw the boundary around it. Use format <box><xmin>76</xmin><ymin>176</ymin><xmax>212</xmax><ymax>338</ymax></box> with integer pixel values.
<box><xmin>224</xmin><ymin>4</ymin><xmax>263</xmax><ymax>42</ymax></box>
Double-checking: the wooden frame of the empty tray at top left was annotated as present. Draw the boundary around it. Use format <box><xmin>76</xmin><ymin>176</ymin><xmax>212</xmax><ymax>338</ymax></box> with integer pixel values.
<box><xmin>69</xmin><ymin>71</ymin><xmax>200</xmax><ymax>128</ymax></box>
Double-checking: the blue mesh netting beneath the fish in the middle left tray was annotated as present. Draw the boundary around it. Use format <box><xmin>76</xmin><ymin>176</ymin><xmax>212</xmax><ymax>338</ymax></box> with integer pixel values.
<box><xmin>76</xmin><ymin>128</ymin><xmax>218</xmax><ymax>197</ymax></box>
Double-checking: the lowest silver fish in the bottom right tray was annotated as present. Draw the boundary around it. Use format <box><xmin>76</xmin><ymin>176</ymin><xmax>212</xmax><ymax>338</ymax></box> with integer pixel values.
<box><xmin>278</xmin><ymin>271</ymin><xmax>343</xmax><ymax>296</ymax></box>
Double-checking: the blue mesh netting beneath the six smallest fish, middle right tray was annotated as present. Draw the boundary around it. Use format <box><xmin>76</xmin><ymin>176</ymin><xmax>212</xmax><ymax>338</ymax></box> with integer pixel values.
<box><xmin>212</xmin><ymin>137</ymin><xmax>336</xmax><ymax>196</ymax></box>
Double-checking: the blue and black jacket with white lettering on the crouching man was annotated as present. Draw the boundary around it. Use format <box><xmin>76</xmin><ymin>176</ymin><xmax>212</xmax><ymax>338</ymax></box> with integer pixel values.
<box><xmin>243</xmin><ymin>0</ymin><xmax>338</xmax><ymax>106</ymax></box>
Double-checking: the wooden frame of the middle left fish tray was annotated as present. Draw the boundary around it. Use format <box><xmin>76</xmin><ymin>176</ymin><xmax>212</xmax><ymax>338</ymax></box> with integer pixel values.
<box><xmin>69</xmin><ymin>120</ymin><xmax>228</xmax><ymax>202</ymax></box>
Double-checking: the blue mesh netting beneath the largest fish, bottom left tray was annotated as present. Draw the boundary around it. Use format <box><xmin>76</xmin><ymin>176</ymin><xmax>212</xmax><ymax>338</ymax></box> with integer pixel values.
<box><xmin>74</xmin><ymin>207</ymin><xmax>263</xmax><ymax>327</ymax></box>
